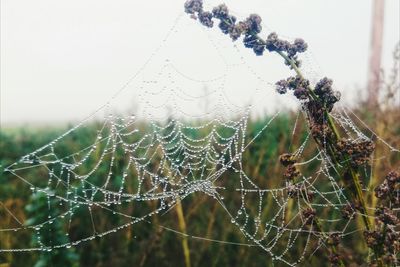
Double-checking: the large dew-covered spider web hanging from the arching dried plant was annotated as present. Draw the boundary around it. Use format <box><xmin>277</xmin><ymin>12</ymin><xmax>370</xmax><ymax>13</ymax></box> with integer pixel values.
<box><xmin>0</xmin><ymin>7</ymin><xmax>399</xmax><ymax>265</ymax></box>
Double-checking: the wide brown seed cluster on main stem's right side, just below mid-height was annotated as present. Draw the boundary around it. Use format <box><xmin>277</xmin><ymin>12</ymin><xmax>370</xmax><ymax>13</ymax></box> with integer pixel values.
<box><xmin>336</xmin><ymin>139</ymin><xmax>375</xmax><ymax>167</ymax></box>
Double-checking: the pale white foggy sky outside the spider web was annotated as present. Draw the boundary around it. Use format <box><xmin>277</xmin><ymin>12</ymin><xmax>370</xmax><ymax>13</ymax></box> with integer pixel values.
<box><xmin>0</xmin><ymin>0</ymin><xmax>400</xmax><ymax>125</ymax></box>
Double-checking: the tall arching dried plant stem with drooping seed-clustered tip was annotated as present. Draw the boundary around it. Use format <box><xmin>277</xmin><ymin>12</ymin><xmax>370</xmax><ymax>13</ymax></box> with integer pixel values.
<box><xmin>185</xmin><ymin>6</ymin><xmax>384</xmax><ymax>266</ymax></box>
